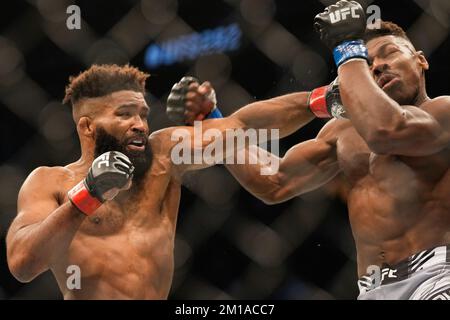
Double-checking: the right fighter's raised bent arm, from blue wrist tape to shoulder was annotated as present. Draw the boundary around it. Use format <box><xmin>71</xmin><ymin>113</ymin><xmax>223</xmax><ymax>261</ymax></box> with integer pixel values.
<box><xmin>339</xmin><ymin>60</ymin><xmax>450</xmax><ymax>156</ymax></box>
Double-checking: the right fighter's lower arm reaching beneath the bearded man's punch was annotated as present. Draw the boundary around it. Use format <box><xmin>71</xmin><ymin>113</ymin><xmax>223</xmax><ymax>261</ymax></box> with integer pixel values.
<box><xmin>226</xmin><ymin>120</ymin><xmax>340</xmax><ymax>204</ymax></box>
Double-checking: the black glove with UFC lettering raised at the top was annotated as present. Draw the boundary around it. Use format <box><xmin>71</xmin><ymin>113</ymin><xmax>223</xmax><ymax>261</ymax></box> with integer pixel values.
<box><xmin>314</xmin><ymin>0</ymin><xmax>366</xmax><ymax>49</ymax></box>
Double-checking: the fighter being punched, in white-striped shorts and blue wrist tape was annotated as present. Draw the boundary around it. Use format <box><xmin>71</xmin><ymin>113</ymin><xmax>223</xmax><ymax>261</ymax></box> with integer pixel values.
<box><xmin>175</xmin><ymin>1</ymin><xmax>450</xmax><ymax>299</ymax></box>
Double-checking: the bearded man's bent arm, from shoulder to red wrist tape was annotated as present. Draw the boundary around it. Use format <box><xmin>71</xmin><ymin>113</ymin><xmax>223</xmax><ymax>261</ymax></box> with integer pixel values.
<box><xmin>6</xmin><ymin>168</ymin><xmax>86</xmax><ymax>282</ymax></box>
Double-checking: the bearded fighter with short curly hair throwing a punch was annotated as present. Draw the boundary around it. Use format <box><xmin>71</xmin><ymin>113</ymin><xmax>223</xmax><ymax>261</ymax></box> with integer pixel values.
<box><xmin>6</xmin><ymin>65</ymin><xmax>313</xmax><ymax>299</ymax></box>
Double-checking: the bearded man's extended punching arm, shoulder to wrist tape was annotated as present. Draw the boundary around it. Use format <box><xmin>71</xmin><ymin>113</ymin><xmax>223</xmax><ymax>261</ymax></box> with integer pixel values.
<box><xmin>158</xmin><ymin>92</ymin><xmax>315</xmax><ymax>175</ymax></box>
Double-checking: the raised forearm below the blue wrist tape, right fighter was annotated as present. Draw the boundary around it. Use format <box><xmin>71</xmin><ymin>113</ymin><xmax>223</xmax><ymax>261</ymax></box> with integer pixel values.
<box><xmin>338</xmin><ymin>60</ymin><xmax>404</xmax><ymax>142</ymax></box>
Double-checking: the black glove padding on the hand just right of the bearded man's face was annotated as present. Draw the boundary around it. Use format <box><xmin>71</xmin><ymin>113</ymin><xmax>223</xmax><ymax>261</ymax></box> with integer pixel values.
<box><xmin>166</xmin><ymin>77</ymin><xmax>199</xmax><ymax>125</ymax></box>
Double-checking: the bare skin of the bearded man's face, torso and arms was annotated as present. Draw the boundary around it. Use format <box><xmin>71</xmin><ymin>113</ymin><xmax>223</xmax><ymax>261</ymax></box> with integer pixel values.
<box><xmin>7</xmin><ymin>90</ymin><xmax>313</xmax><ymax>299</ymax></box>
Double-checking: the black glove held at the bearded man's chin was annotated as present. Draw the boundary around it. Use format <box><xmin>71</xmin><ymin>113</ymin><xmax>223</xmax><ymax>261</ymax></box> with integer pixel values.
<box><xmin>85</xmin><ymin>151</ymin><xmax>134</xmax><ymax>202</ymax></box>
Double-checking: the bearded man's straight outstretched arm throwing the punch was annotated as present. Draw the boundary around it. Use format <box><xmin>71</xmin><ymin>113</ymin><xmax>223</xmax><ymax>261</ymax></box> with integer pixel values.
<box><xmin>172</xmin><ymin>92</ymin><xmax>315</xmax><ymax>175</ymax></box>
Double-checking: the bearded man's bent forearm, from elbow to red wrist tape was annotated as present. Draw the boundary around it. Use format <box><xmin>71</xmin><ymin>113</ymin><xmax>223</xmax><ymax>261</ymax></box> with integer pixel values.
<box><xmin>7</xmin><ymin>202</ymin><xmax>86</xmax><ymax>282</ymax></box>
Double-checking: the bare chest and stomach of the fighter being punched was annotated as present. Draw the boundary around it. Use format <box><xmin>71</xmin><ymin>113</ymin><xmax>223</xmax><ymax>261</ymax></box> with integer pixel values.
<box><xmin>335</xmin><ymin>109</ymin><xmax>450</xmax><ymax>276</ymax></box>
